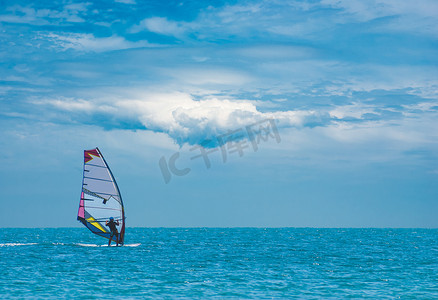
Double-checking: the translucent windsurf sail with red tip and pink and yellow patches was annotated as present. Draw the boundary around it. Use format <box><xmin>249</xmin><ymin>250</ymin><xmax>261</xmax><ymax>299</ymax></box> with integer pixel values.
<box><xmin>78</xmin><ymin>148</ymin><xmax>125</xmax><ymax>244</ymax></box>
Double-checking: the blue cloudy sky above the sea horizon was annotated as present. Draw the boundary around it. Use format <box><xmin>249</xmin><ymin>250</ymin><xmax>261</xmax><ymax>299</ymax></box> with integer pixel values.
<box><xmin>0</xmin><ymin>0</ymin><xmax>438</xmax><ymax>228</ymax></box>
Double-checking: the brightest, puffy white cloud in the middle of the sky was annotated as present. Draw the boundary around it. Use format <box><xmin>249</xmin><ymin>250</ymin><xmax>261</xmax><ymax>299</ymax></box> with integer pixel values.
<box><xmin>38</xmin><ymin>93</ymin><xmax>326</xmax><ymax>144</ymax></box>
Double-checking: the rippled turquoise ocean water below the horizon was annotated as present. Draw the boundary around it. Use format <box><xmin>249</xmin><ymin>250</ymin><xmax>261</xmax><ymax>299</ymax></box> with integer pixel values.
<box><xmin>0</xmin><ymin>228</ymin><xmax>438</xmax><ymax>299</ymax></box>
